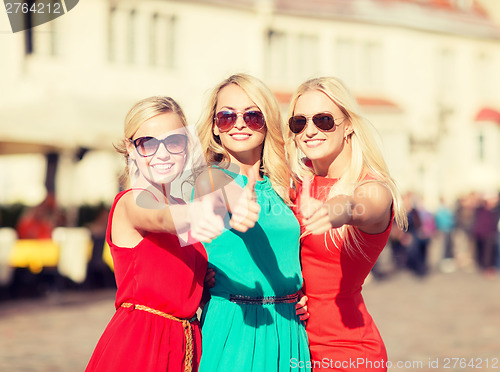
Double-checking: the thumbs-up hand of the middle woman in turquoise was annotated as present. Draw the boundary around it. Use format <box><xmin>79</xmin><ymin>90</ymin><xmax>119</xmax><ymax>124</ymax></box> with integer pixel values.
<box><xmin>229</xmin><ymin>173</ymin><xmax>260</xmax><ymax>232</ymax></box>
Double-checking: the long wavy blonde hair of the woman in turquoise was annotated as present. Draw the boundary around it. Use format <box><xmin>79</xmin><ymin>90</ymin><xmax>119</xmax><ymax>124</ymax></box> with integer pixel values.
<box><xmin>197</xmin><ymin>74</ymin><xmax>291</xmax><ymax>205</ymax></box>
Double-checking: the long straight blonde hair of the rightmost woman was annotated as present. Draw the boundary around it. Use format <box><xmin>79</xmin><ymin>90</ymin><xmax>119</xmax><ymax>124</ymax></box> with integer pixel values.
<box><xmin>286</xmin><ymin>77</ymin><xmax>407</xmax><ymax>256</ymax></box>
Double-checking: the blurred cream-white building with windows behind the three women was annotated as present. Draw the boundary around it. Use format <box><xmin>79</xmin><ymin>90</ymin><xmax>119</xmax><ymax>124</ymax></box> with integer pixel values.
<box><xmin>0</xmin><ymin>0</ymin><xmax>500</xmax><ymax>206</ymax></box>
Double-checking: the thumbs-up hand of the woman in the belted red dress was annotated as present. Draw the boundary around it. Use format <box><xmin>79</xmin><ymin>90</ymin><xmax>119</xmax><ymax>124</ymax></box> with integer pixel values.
<box><xmin>190</xmin><ymin>193</ymin><xmax>224</xmax><ymax>243</ymax></box>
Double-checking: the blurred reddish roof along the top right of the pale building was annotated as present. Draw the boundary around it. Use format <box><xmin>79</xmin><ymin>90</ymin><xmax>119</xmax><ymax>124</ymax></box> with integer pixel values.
<box><xmin>189</xmin><ymin>0</ymin><xmax>500</xmax><ymax>40</ymax></box>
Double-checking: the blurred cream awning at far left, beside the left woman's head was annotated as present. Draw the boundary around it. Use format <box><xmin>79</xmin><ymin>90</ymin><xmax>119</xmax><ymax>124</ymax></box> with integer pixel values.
<box><xmin>0</xmin><ymin>96</ymin><xmax>129</xmax><ymax>155</ymax></box>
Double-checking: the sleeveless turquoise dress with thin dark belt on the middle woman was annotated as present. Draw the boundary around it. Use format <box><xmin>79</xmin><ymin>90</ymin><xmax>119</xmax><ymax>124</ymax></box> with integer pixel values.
<box><xmin>199</xmin><ymin>170</ymin><xmax>310</xmax><ymax>372</ymax></box>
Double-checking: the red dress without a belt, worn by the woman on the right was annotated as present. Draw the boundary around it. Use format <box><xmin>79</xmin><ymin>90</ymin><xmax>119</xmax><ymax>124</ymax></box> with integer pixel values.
<box><xmin>297</xmin><ymin>176</ymin><xmax>392</xmax><ymax>372</ymax></box>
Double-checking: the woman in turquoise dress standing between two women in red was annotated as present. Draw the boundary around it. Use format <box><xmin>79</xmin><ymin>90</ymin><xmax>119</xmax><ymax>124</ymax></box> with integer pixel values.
<box><xmin>195</xmin><ymin>74</ymin><xmax>310</xmax><ymax>372</ymax></box>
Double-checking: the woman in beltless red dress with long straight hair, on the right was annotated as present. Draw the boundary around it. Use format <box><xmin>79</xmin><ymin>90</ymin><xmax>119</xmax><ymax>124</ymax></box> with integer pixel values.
<box><xmin>287</xmin><ymin>77</ymin><xmax>406</xmax><ymax>371</ymax></box>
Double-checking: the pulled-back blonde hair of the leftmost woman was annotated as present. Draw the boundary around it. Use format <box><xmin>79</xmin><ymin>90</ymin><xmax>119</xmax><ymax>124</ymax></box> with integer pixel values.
<box><xmin>114</xmin><ymin>96</ymin><xmax>188</xmax><ymax>184</ymax></box>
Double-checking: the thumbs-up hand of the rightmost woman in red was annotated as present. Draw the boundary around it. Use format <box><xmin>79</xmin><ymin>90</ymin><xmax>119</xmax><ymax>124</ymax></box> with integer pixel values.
<box><xmin>300</xmin><ymin>178</ymin><xmax>332</xmax><ymax>235</ymax></box>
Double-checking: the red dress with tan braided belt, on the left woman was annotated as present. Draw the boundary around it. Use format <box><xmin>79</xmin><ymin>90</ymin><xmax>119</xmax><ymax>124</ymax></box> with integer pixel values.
<box><xmin>86</xmin><ymin>190</ymin><xmax>207</xmax><ymax>372</ymax></box>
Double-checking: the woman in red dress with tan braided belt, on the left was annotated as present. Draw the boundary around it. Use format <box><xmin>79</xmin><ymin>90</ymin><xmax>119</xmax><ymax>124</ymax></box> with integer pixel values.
<box><xmin>86</xmin><ymin>97</ymin><xmax>223</xmax><ymax>372</ymax></box>
